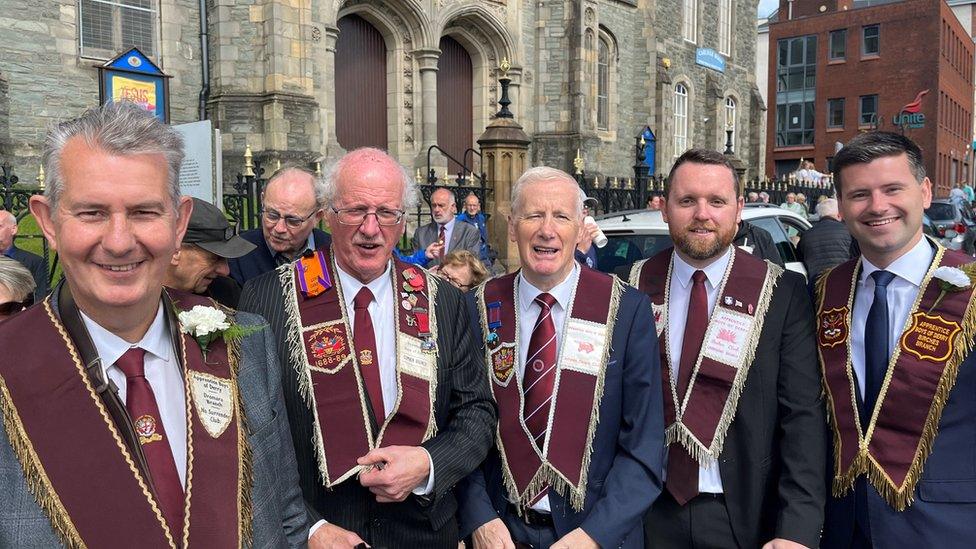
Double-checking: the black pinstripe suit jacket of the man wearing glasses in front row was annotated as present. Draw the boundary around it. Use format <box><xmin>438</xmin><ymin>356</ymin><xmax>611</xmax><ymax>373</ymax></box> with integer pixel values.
<box><xmin>240</xmin><ymin>264</ymin><xmax>497</xmax><ymax>549</ymax></box>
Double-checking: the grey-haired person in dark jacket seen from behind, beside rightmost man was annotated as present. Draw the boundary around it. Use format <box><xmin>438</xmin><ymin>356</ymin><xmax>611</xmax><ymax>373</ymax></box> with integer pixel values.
<box><xmin>797</xmin><ymin>198</ymin><xmax>852</xmax><ymax>282</ymax></box>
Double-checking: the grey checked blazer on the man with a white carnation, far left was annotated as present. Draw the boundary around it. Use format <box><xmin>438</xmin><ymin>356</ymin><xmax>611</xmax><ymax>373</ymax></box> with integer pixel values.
<box><xmin>0</xmin><ymin>290</ymin><xmax>309</xmax><ymax>549</ymax></box>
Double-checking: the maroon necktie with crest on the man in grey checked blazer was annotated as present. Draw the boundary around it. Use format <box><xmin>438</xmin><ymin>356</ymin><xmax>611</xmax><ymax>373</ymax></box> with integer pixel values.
<box><xmin>115</xmin><ymin>347</ymin><xmax>183</xmax><ymax>539</ymax></box>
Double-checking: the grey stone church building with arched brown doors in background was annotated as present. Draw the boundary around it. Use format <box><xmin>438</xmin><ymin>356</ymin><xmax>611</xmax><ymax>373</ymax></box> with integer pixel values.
<box><xmin>0</xmin><ymin>0</ymin><xmax>765</xmax><ymax>181</ymax></box>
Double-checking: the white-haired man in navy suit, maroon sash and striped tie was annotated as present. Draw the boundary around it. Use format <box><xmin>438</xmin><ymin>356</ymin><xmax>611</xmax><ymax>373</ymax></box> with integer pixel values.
<box><xmin>459</xmin><ymin>167</ymin><xmax>664</xmax><ymax>549</ymax></box>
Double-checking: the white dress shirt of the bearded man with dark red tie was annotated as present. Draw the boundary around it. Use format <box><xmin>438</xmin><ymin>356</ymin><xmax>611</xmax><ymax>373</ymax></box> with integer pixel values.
<box><xmin>664</xmin><ymin>247</ymin><xmax>732</xmax><ymax>494</ymax></box>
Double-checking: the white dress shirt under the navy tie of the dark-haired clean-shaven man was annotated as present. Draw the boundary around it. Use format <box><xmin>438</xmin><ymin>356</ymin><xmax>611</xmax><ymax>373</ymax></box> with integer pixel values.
<box><xmin>851</xmin><ymin>236</ymin><xmax>935</xmax><ymax>398</ymax></box>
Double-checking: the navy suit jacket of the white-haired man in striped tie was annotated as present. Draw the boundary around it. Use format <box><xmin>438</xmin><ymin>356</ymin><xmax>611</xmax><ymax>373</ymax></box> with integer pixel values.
<box><xmin>458</xmin><ymin>276</ymin><xmax>664</xmax><ymax>548</ymax></box>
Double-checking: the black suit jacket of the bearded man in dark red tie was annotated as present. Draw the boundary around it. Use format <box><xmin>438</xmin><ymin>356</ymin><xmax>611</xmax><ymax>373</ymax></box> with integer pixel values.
<box><xmin>651</xmin><ymin>256</ymin><xmax>827</xmax><ymax>548</ymax></box>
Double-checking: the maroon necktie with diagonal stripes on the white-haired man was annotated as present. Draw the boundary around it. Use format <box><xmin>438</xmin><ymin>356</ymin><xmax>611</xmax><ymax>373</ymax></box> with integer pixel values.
<box><xmin>522</xmin><ymin>292</ymin><xmax>558</xmax><ymax>450</ymax></box>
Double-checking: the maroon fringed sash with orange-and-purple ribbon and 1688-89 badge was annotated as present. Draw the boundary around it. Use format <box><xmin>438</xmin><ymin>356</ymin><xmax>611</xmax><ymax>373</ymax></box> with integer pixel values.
<box><xmin>279</xmin><ymin>250</ymin><xmax>437</xmax><ymax>487</ymax></box>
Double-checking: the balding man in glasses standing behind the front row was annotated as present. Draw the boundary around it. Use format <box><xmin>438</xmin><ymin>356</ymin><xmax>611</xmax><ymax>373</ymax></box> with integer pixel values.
<box><xmin>229</xmin><ymin>167</ymin><xmax>331</xmax><ymax>284</ymax></box>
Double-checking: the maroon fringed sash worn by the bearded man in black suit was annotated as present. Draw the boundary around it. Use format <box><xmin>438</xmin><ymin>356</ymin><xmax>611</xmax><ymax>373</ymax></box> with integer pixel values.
<box><xmin>630</xmin><ymin>248</ymin><xmax>783</xmax><ymax>465</ymax></box>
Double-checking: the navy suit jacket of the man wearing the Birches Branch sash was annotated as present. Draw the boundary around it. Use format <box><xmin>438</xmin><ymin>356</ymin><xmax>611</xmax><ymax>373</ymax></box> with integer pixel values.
<box><xmin>821</xmin><ymin>282</ymin><xmax>976</xmax><ymax>549</ymax></box>
